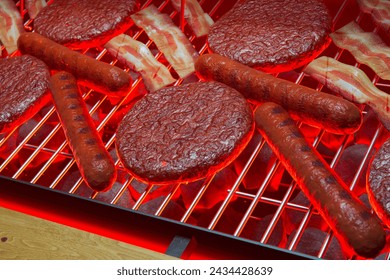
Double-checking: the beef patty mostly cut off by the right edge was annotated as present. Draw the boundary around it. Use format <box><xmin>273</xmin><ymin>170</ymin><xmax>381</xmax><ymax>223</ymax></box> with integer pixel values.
<box><xmin>367</xmin><ymin>138</ymin><xmax>390</xmax><ymax>227</ymax></box>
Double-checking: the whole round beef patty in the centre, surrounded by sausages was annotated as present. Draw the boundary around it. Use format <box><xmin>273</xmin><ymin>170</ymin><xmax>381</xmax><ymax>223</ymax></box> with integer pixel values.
<box><xmin>116</xmin><ymin>82</ymin><xmax>254</xmax><ymax>184</ymax></box>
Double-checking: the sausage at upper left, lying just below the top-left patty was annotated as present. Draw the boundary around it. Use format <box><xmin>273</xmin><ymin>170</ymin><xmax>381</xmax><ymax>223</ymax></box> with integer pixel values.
<box><xmin>18</xmin><ymin>32</ymin><xmax>131</xmax><ymax>96</ymax></box>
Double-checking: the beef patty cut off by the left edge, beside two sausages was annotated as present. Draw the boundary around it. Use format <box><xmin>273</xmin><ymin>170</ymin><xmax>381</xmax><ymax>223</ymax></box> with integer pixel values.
<box><xmin>0</xmin><ymin>55</ymin><xmax>50</xmax><ymax>133</ymax></box>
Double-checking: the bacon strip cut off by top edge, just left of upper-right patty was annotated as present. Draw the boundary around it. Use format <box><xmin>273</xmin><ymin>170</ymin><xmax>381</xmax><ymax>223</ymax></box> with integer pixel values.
<box><xmin>171</xmin><ymin>0</ymin><xmax>214</xmax><ymax>37</ymax></box>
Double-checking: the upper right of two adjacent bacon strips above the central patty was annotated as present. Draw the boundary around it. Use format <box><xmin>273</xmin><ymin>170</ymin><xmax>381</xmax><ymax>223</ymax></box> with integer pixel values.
<box><xmin>131</xmin><ymin>5</ymin><xmax>199</xmax><ymax>78</ymax></box>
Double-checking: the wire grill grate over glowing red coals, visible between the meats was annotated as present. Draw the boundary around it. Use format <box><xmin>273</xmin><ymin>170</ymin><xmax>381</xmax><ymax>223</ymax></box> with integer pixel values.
<box><xmin>0</xmin><ymin>0</ymin><xmax>390</xmax><ymax>259</ymax></box>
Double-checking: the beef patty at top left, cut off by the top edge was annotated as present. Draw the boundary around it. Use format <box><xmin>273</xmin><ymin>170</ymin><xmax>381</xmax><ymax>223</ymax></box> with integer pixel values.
<box><xmin>34</xmin><ymin>0</ymin><xmax>138</xmax><ymax>48</ymax></box>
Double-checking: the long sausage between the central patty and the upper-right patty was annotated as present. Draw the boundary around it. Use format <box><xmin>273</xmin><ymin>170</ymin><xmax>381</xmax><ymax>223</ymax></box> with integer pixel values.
<box><xmin>195</xmin><ymin>54</ymin><xmax>363</xmax><ymax>134</ymax></box>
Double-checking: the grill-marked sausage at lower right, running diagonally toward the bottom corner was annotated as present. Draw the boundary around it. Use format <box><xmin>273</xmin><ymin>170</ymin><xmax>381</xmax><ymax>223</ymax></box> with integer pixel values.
<box><xmin>255</xmin><ymin>102</ymin><xmax>386</xmax><ymax>258</ymax></box>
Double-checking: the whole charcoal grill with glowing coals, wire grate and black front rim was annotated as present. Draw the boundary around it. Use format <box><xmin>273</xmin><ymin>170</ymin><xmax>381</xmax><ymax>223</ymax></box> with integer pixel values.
<box><xmin>0</xmin><ymin>0</ymin><xmax>390</xmax><ymax>259</ymax></box>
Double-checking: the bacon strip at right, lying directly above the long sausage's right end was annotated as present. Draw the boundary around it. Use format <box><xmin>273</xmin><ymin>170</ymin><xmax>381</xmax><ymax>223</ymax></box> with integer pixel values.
<box><xmin>304</xmin><ymin>56</ymin><xmax>390</xmax><ymax>131</ymax></box>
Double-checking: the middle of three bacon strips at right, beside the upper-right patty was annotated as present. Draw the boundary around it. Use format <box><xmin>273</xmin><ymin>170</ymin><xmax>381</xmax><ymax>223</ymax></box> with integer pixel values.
<box><xmin>330</xmin><ymin>21</ymin><xmax>390</xmax><ymax>80</ymax></box>
